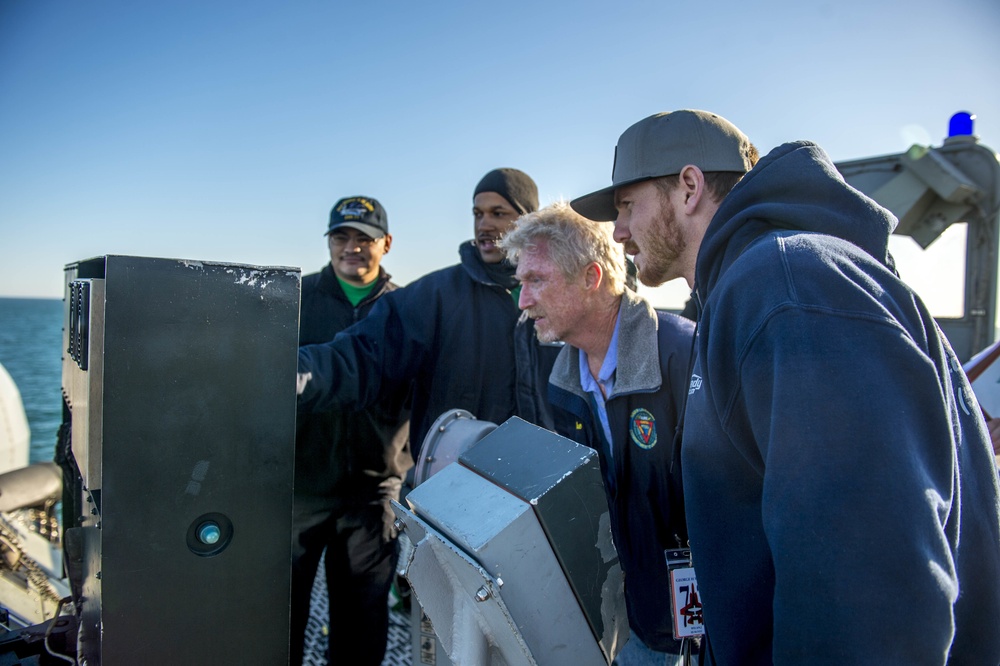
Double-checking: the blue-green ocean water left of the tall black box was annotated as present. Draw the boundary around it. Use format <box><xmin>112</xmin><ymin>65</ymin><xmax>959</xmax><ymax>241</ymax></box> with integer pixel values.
<box><xmin>0</xmin><ymin>298</ymin><xmax>62</xmax><ymax>462</ymax></box>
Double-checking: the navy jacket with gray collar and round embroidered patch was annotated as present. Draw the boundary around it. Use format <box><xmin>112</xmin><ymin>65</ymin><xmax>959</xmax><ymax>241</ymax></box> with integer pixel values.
<box><xmin>549</xmin><ymin>291</ymin><xmax>694</xmax><ymax>653</ymax></box>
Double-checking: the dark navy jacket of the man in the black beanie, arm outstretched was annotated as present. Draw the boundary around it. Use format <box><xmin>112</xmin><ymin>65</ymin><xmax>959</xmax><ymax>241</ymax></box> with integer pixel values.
<box><xmin>299</xmin><ymin>242</ymin><xmax>558</xmax><ymax>457</ymax></box>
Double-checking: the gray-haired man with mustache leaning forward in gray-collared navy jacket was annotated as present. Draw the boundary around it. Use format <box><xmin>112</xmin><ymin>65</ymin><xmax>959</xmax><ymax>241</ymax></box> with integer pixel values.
<box><xmin>502</xmin><ymin>202</ymin><xmax>699</xmax><ymax>665</ymax></box>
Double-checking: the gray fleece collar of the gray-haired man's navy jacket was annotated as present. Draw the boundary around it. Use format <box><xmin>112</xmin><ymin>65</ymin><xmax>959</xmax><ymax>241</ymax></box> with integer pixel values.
<box><xmin>549</xmin><ymin>289</ymin><xmax>663</xmax><ymax>400</ymax></box>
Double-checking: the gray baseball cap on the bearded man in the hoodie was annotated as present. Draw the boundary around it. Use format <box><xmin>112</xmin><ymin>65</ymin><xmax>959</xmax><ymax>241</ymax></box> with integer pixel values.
<box><xmin>570</xmin><ymin>109</ymin><xmax>753</xmax><ymax>221</ymax></box>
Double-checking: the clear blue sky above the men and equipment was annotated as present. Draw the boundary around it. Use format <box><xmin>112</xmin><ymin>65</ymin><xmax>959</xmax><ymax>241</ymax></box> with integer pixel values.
<box><xmin>0</xmin><ymin>0</ymin><xmax>1000</xmax><ymax>306</ymax></box>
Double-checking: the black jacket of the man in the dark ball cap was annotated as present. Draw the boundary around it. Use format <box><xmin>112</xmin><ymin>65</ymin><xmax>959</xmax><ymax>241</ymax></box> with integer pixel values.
<box><xmin>295</xmin><ymin>264</ymin><xmax>413</xmax><ymax>504</ymax></box>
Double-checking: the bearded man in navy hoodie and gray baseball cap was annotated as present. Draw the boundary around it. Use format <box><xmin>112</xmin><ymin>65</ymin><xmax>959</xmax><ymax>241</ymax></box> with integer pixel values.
<box><xmin>572</xmin><ymin>111</ymin><xmax>1000</xmax><ymax>665</ymax></box>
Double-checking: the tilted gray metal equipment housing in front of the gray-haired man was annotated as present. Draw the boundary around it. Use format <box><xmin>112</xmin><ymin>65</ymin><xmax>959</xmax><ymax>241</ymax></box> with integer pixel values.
<box><xmin>393</xmin><ymin>417</ymin><xmax>628</xmax><ymax>666</ymax></box>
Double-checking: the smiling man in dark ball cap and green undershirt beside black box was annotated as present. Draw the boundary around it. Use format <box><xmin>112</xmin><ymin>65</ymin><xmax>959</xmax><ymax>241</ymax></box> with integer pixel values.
<box><xmin>290</xmin><ymin>196</ymin><xmax>413</xmax><ymax>666</ymax></box>
